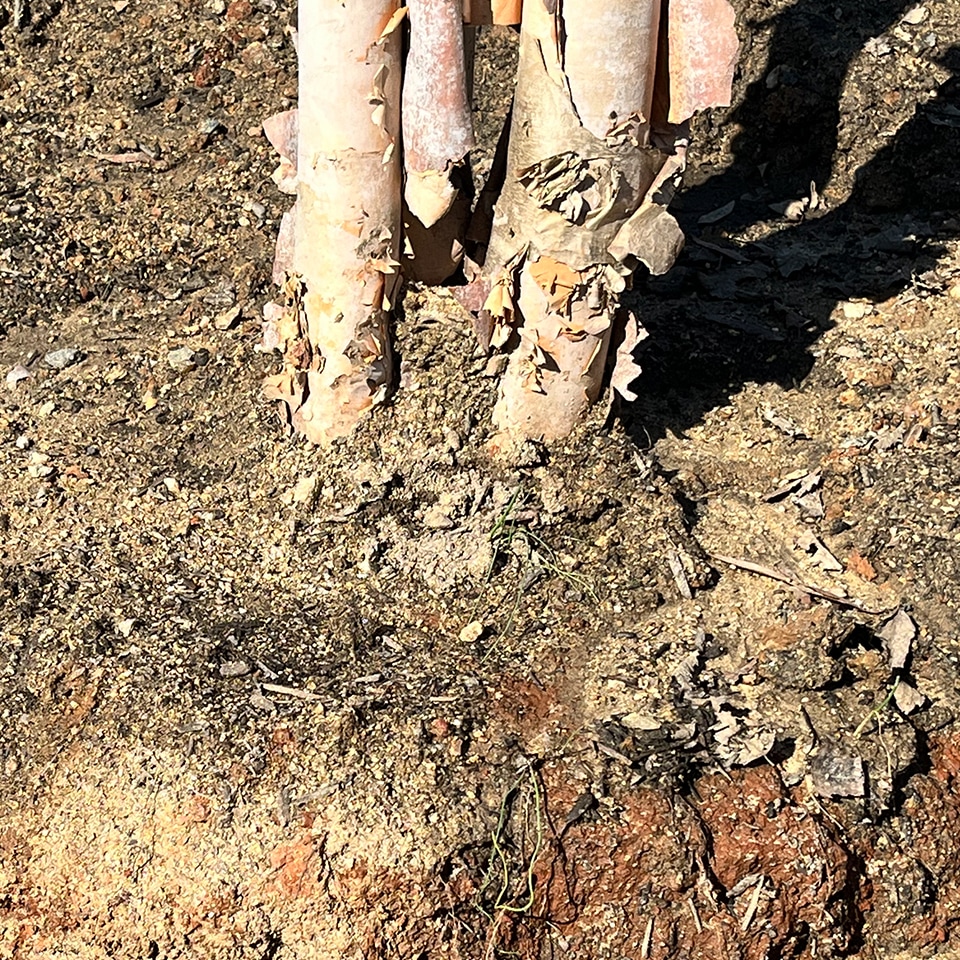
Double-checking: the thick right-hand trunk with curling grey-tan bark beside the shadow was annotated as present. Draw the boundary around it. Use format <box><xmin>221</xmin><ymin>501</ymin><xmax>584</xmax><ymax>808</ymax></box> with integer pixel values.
<box><xmin>485</xmin><ymin>0</ymin><xmax>737</xmax><ymax>439</ymax></box>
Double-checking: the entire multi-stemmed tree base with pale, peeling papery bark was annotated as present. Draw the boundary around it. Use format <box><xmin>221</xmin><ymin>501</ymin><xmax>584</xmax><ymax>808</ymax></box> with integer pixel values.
<box><xmin>265</xmin><ymin>0</ymin><xmax>737</xmax><ymax>443</ymax></box>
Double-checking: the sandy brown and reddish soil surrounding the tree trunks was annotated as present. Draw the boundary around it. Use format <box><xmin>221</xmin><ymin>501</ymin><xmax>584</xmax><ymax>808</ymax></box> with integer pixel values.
<box><xmin>0</xmin><ymin>0</ymin><xmax>960</xmax><ymax>960</ymax></box>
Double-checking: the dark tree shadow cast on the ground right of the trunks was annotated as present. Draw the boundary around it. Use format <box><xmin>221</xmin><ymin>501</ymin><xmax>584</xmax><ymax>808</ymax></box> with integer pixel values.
<box><xmin>623</xmin><ymin>0</ymin><xmax>960</xmax><ymax>446</ymax></box>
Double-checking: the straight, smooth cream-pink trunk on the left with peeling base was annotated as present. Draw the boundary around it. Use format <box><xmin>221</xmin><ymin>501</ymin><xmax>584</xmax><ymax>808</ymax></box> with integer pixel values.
<box><xmin>265</xmin><ymin>0</ymin><xmax>403</xmax><ymax>444</ymax></box>
